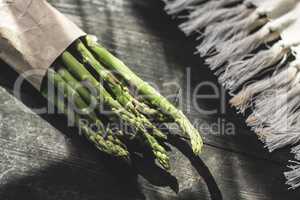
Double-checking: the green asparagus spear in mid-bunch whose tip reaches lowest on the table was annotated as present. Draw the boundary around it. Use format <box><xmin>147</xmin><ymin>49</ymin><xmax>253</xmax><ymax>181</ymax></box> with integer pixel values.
<box><xmin>61</xmin><ymin>51</ymin><xmax>169</xmax><ymax>169</ymax></box>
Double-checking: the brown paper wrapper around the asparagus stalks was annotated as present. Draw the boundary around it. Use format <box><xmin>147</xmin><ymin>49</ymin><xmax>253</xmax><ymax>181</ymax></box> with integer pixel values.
<box><xmin>0</xmin><ymin>0</ymin><xmax>86</xmax><ymax>90</ymax></box>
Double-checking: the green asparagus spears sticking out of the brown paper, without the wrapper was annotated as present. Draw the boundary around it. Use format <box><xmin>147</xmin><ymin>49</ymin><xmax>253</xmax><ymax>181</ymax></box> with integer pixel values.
<box><xmin>41</xmin><ymin>36</ymin><xmax>203</xmax><ymax>169</ymax></box>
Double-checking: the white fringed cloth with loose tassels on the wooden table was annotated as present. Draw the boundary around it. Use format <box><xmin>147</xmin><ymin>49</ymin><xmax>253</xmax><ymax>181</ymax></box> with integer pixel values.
<box><xmin>165</xmin><ymin>0</ymin><xmax>300</xmax><ymax>189</ymax></box>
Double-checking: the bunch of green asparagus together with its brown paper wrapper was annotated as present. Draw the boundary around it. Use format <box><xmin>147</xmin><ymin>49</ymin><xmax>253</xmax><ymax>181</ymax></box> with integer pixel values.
<box><xmin>0</xmin><ymin>0</ymin><xmax>203</xmax><ymax>169</ymax></box>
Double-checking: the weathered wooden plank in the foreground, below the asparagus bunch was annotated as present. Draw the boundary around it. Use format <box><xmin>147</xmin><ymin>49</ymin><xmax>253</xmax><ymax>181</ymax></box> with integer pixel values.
<box><xmin>0</xmin><ymin>88</ymin><xmax>299</xmax><ymax>200</ymax></box>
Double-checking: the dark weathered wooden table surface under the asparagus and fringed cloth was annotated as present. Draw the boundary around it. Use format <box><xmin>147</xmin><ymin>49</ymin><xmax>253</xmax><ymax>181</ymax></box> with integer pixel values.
<box><xmin>0</xmin><ymin>0</ymin><xmax>300</xmax><ymax>200</ymax></box>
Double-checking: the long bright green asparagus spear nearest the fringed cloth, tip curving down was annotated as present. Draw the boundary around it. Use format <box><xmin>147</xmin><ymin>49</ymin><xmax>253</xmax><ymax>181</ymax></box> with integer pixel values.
<box><xmin>84</xmin><ymin>36</ymin><xmax>203</xmax><ymax>154</ymax></box>
